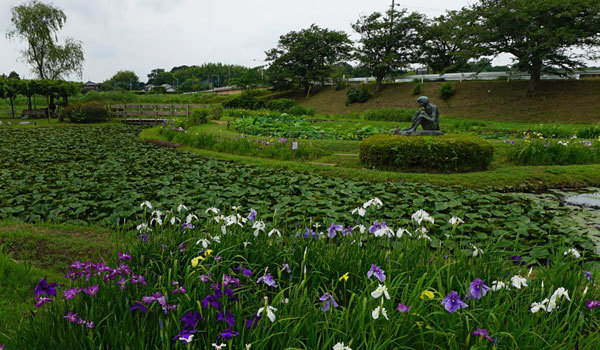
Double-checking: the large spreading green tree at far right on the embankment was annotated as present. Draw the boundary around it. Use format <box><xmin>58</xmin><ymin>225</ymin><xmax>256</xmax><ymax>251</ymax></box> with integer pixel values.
<box><xmin>462</xmin><ymin>0</ymin><xmax>600</xmax><ymax>93</ymax></box>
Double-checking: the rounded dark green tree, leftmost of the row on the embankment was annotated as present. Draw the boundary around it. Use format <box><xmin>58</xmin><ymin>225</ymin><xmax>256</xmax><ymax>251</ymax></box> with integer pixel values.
<box><xmin>265</xmin><ymin>24</ymin><xmax>352</xmax><ymax>96</ymax></box>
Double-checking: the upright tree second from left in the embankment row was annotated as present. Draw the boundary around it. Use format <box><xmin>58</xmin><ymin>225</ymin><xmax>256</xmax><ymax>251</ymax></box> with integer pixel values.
<box><xmin>352</xmin><ymin>5</ymin><xmax>425</xmax><ymax>92</ymax></box>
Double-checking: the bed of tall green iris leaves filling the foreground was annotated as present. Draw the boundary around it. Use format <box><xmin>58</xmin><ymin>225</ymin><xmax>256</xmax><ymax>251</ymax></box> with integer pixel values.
<box><xmin>8</xmin><ymin>204</ymin><xmax>600</xmax><ymax>349</ymax></box>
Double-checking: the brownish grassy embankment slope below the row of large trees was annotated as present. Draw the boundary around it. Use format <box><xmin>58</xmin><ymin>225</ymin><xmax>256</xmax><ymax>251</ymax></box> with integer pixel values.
<box><xmin>292</xmin><ymin>80</ymin><xmax>600</xmax><ymax>123</ymax></box>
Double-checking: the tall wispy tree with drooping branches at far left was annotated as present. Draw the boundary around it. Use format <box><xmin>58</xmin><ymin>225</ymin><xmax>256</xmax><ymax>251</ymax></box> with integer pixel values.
<box><xmin>7</xmin><ymin>0</ymin><xmax>83</xmax><ymax>79</ymax></box>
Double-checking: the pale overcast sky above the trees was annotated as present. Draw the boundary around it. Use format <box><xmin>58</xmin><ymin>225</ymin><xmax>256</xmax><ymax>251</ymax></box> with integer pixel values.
<box><xmin>0</xmin><ymin>0</ymin><xmax>510</xmax><ymax>82</ymax></box>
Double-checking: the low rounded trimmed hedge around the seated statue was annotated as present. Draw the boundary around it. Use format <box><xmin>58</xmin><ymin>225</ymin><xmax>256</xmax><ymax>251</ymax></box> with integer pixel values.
<box><xmin>360</xmin><ymin>134</ymin><xmax>494</xmax><ymax>173</ymax></box>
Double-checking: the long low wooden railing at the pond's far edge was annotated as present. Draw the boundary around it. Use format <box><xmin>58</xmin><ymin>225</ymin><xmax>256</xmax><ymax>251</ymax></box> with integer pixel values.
<box><xmin>108</xmin><ymin>104</ymin><xmax>210</xmax><ymax>118</ymax></box>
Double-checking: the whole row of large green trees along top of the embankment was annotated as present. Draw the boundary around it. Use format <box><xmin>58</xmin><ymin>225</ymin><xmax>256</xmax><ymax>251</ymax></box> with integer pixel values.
<box><xmin>266</xmin><ymin>0</ymin><xmax>600</xmax><ymax>94</ymax></box>
